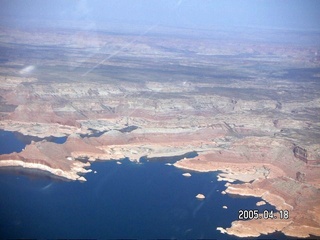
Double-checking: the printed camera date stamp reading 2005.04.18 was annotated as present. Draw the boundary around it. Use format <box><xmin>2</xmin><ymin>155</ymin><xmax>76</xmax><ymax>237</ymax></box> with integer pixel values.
<box><xmin>238</xmin><ymin>209</ymin><xmax>289</xmax><ymax>220</ymax></box>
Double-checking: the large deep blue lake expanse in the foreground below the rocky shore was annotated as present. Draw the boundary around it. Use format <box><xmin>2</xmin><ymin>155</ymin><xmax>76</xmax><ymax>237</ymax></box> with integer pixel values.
<box><xmin>0</xmin><ymin>131</ymin><xmax>285</xmax><ymax>239</ymax></box>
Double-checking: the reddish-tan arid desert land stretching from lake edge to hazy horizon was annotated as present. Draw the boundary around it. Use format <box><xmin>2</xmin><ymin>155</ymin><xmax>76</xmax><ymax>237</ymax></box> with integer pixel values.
<box><xmin>0</xmin><ymin>28</ymin><xmax>320</xmax><ymax>237</ymax></box>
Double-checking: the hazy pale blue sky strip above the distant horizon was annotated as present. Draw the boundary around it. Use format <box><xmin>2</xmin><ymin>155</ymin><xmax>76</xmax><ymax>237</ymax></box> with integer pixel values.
<box><xmin>0</xmin><ymin>0</ymin><xmax>320</xmax><ymax>29</ymax></box>
